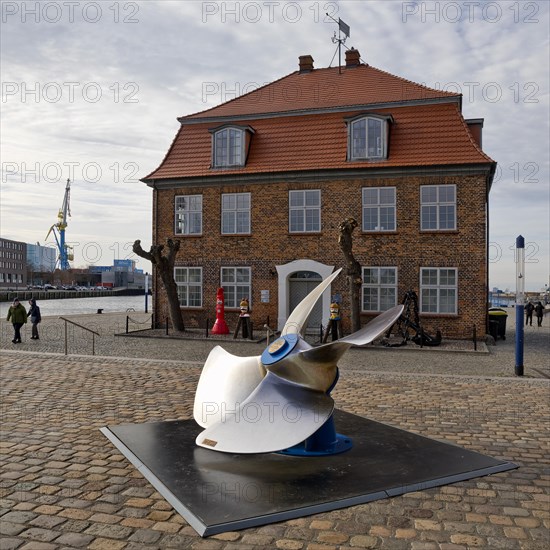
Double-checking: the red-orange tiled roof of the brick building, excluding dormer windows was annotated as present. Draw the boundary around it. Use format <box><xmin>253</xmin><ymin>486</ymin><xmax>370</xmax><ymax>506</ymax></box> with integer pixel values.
<box><xmin>144</xmin><ymin>65</ymin><xmax>493</xmax><ymax>181</ymax></box>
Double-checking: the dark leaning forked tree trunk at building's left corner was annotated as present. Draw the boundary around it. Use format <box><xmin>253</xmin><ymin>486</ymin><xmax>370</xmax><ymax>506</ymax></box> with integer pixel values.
<box><xmin>132</xmin><ymin>239</ymin><xmax>185</xmax><ymax>332</ymax></box>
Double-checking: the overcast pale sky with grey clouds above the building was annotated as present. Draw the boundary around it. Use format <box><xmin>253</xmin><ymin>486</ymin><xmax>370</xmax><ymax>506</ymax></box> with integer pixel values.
<box><xmin>0</xmin><ymin>0</ymin><xmax>550</xmax><ymax>290</ymax></box>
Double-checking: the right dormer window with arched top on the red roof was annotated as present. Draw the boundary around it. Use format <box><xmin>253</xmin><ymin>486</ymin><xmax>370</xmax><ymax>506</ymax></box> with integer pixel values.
<box><xmin>347</xmin><ymin>115</ymin><xmax>392</xmax><ymax>160</ymax></box>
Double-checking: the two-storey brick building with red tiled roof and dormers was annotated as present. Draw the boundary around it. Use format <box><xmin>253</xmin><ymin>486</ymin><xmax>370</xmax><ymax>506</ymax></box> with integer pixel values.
<box><xmin>143</xmin><ymin>49</ymin><xmax>496</xmax><ymax>338</ymax></box>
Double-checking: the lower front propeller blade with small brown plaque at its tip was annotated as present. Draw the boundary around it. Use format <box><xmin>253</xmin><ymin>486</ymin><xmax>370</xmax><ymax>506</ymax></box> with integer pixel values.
<box><xmin>196</xmin><ymin>372</ymin><xmax>334</xmax><ymax>454</ymax></box>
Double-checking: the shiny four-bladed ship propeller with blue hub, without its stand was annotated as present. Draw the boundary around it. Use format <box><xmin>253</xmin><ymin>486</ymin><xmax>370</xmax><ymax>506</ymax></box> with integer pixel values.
<box><xmin>193</xmin><ymin>269</ymin><xmax>403</xmax><ymax>454</ymax></box>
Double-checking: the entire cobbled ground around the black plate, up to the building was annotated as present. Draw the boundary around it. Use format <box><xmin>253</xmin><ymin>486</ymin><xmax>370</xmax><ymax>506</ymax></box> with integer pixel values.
<box><xmin>0</xmin><ymin>308</ymin><xmax>550</xmax><ymax>550</ymax></box>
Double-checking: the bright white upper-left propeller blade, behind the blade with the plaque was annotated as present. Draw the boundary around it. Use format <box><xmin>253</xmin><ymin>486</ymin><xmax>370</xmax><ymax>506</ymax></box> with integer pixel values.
<box><xmin>193</xmin><ymin>346</ymin><xmax>266</xmax><ymax>428</ymax></box>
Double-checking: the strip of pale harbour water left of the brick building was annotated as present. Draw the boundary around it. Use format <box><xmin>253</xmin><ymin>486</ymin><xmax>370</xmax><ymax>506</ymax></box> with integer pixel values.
<box><xmin>0</xmin><ymin>295</ymin><xmax>153</xmax><ymax>319</ymax></box>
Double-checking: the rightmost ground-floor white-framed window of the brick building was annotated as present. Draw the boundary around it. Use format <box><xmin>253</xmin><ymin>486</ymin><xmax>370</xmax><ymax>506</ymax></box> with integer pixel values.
<box><xmin>419</xmin><ymin>267</ymin><xmax>458</xmax><ymax>315</ymax></box>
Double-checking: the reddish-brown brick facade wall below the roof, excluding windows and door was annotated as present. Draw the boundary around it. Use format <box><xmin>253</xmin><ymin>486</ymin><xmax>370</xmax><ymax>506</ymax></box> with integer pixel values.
<box><xmin>153</xmin><ymin>175</ymin><xmax>487</xmax><ymax>338</ymax></box>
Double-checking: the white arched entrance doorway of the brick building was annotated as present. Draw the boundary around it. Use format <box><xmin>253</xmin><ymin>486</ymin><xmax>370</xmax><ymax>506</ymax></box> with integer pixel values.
<box><xmin>275</xmin><ymin>260</ymin><xmax>334</xmax><ymax>330</ymax></box>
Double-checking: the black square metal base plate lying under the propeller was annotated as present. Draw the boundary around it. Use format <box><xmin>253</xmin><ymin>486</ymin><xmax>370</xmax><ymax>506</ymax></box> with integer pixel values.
<box><xmin>101</xmin><ymin>410</ymin><xmax>517</xmax><ymax>537</ymax></box>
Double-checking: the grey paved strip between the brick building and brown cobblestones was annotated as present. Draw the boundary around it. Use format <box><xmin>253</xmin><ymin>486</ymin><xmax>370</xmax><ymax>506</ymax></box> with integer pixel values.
<box><xmin>0</xmin><ymin>308</ymin><xmax>550</xmax><ymax>378</ymax></box>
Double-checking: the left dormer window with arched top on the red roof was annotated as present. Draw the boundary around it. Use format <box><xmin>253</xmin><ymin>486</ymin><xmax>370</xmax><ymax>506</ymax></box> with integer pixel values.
<box><xmin>209</xmin><ymin>126</ymin><xmax>254</xmax><ymax>168</ymax></box>
